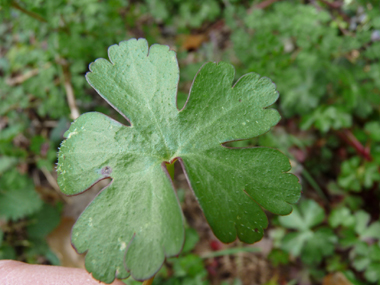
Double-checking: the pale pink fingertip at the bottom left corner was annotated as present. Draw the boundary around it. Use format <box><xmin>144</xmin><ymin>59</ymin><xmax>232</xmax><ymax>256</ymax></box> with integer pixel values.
<box><xmin>0</xmin><ymin>260</ymin><xmax>124</xmax><ymax>285</ymax></box>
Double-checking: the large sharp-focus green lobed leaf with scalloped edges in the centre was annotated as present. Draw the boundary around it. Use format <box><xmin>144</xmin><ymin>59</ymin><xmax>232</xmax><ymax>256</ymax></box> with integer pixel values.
<box><xmin>57</xmin><ymin>39</ymin><xmax>300</xmax><ymax>282</ymax></box>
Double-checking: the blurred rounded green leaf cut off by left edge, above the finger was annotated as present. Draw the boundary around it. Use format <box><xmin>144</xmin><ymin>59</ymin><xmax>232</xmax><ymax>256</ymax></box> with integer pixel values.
<box><xmin>0</xmin><ymin>170</ymin><xmax>42</xmax><ymax>220</ymax></box>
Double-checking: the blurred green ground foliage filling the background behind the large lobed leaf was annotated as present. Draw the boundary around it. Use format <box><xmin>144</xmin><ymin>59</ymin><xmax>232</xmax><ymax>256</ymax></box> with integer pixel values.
<box><xmin>0</xmin><ymin>0</ymin><xmax>380</xmax><ymax>284</ymax></box>
